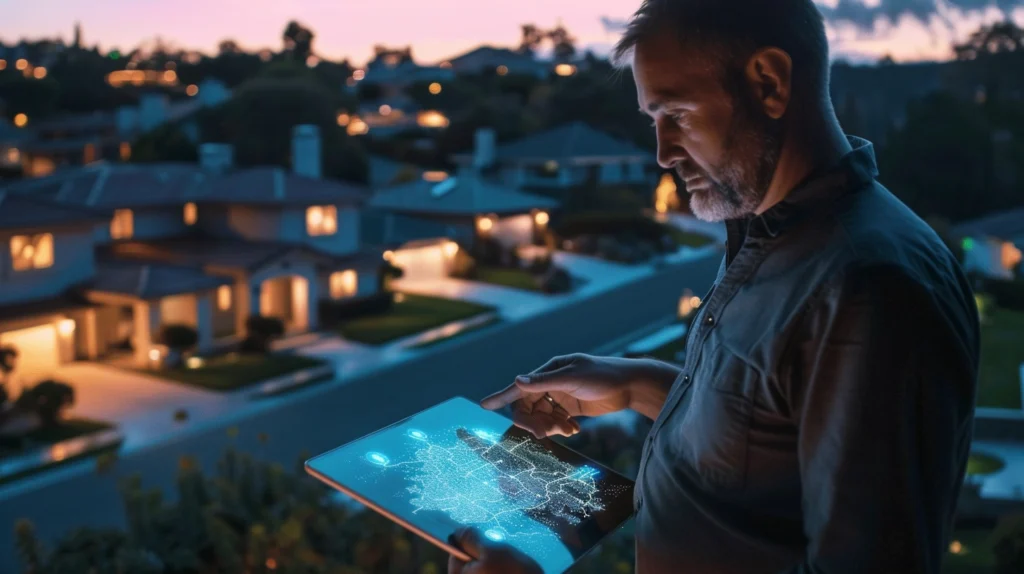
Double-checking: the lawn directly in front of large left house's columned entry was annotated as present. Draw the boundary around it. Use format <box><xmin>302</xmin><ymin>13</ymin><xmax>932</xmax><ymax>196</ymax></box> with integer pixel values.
<box><xmin>150</xmin><ymin>353</ymin><xmax>326</xmax><ymax>391</ymax></box>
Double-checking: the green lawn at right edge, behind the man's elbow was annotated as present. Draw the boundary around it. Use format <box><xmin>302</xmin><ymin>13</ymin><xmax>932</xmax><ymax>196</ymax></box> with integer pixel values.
<box><xmin>978</xmin><ymin>308</ymin><xmax>1024</xmax><ymax>408</ymax></box>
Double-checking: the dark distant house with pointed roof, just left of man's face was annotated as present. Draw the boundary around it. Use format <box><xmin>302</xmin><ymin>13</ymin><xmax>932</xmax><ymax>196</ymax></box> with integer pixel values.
<box><xmin>453</xmin><ymin>122</ymin><xmax>659</xmax><ymax>192</ymax></box>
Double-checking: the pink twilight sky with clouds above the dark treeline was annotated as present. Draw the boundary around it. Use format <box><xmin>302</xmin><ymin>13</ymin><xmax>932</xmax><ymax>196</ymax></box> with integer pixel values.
<box><xmin>0</xmin><ymin>0</ymin><xmax>1024</xmax><ymax>63</ymax></box>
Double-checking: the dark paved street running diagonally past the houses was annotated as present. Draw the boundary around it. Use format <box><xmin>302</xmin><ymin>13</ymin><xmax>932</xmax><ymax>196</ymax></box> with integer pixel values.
<box><xmin>0</xmin><ymin>254</ymin><xmax>720</xmax><ymax>572</ymax></box>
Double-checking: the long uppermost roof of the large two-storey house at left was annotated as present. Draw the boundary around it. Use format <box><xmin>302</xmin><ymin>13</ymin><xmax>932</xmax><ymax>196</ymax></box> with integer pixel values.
<box><xmin>8</xmin><ymin>163</ymin><xmax>369</xmax><ymax>209</ymax></box>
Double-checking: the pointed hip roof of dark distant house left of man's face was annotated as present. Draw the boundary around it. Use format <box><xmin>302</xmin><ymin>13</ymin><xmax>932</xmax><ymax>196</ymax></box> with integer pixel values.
<box><xmin>485</xmin><ymin>122</ymin><xmax>653</xmax><ymax>162</ymax></box>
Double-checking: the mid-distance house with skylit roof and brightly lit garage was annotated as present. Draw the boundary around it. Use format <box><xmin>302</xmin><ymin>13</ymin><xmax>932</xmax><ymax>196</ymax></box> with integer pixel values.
<box><xmin>368</xmin><ymin>131</ymin><xmax>558</xmax><ymax>279</ymax></box>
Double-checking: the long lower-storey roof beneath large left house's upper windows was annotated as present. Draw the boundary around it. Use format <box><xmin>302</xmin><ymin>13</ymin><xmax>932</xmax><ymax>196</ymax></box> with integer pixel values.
<box><xmin>110</xmin><ymin>237</ymin><xmax>383</xmax><ymax>271</ymax></box>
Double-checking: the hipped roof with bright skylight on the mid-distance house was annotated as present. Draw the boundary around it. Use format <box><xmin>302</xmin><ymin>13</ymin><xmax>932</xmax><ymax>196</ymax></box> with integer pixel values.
<box><xmin>370</xmin><ymin>173</ymin><xmax>558</xmax><ymax>216</ymax></box>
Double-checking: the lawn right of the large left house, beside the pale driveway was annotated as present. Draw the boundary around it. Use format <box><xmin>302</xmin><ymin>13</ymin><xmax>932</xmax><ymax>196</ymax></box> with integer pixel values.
<box><xmin>338</xmin><ymin>294</ymin><xmax>494</xmax><ymax>345</ymax></box>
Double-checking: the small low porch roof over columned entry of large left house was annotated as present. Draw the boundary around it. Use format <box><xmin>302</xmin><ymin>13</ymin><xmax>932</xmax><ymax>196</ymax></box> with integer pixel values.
<box><xmin>89</xmin><ymin>258</ymin><xmax>232</xmax><ymax>299</ymax></box>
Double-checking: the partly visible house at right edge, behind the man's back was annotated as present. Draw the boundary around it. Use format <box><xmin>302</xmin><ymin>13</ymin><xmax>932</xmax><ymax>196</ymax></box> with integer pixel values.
<box><xmin>953</xmin><ymin>208</ymin><xmax>1024</xmax><ymax>279</ymax></box>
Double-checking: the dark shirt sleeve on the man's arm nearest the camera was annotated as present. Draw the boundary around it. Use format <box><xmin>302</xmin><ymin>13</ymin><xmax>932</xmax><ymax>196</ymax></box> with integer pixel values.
<box><xmin>787</xmin><ymin>268</ymin><xmax>977</xmax><ymax>574</ymax></box>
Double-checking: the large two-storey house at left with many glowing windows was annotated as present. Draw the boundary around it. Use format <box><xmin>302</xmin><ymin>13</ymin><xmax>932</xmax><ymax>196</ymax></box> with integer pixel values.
<box><xmin>0</xmin><ymin>126</ymin><xmax>383</xmax><ymax>376</ymax></box>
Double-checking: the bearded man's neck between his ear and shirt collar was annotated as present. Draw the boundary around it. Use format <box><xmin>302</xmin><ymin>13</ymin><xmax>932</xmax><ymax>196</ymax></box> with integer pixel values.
<box><xmin>755</xmin><ymin>106</ymin><xmax>852</xmax><ymax>215</ymax></box>
